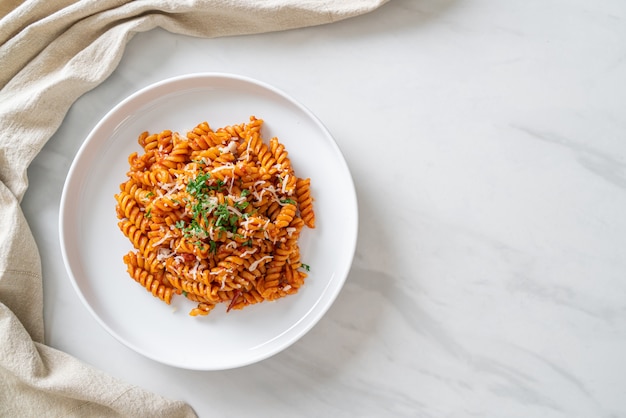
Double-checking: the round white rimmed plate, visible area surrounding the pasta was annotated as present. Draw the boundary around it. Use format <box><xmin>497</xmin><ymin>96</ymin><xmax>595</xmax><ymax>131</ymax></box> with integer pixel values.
<box><xmin>60</xmin><ymin>73</ymin><xmax>358</xmax><ymax>370</ymax></box>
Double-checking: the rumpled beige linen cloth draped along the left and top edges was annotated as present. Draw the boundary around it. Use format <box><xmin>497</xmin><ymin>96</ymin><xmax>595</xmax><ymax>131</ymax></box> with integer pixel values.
<box><xmin>0</xmin><ymin>0</ymin><xmax>387</xmax><ymax>417</ymax></box>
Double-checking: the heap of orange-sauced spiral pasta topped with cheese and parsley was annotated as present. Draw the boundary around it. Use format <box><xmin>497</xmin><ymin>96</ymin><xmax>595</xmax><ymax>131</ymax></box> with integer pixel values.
<box><xmin>115</xmin><ymin>116</ymin><xmax>315</xmax><ymax>316</ymax></box>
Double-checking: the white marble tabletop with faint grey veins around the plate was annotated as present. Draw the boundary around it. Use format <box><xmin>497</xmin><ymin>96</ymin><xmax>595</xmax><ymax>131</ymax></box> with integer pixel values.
<box><xmin>23</xmin><ymin>0</ymin><xmax>626</xmax><ymax>418</ymax></box>
